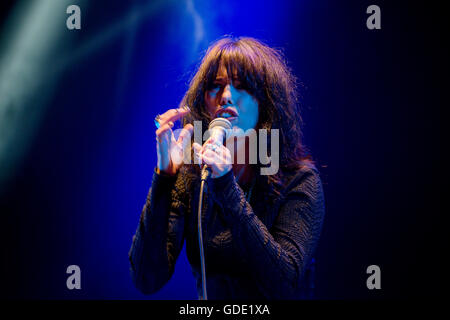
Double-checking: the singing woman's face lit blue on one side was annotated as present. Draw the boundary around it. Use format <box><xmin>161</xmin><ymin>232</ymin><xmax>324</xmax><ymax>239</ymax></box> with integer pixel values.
<box><xmin>205</xmin><ymin>65</ymin><xmax>259</xmax><ymax>132</ymax></box>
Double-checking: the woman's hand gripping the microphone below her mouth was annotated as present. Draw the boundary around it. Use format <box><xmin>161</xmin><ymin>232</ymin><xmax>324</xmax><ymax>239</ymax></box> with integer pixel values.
<box><xmin>192</xmin><ymin>138</ymin><xmax>233</xmax><ymax>178</ymax></box>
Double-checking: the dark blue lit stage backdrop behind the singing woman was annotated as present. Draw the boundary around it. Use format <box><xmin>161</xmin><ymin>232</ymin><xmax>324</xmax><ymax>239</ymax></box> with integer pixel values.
<box><xmin>0</xmin><ymin>0</ymin><xmax>442</xmax><ymax>299</ymax></box>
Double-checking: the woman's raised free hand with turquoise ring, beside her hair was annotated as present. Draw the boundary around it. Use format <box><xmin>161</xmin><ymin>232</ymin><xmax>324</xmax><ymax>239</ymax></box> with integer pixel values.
<box><xmin>156</xmin><ymin>106</ymin><xmax>194</xmax><ymax>175</ymax></box>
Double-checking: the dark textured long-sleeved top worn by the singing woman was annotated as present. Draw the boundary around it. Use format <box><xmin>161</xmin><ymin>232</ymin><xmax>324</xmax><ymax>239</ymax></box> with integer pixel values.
<box><xmin>129</xmin><ymin>166</ymin><xmax>324</xmax><ymax>299</ymax></box>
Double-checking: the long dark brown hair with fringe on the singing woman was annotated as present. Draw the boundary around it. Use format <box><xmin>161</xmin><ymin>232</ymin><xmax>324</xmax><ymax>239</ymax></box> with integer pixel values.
<box><xmin>180</xmin><ymin>37</ymin><xmax>313</xmax><ymax>192</ymax></box>
